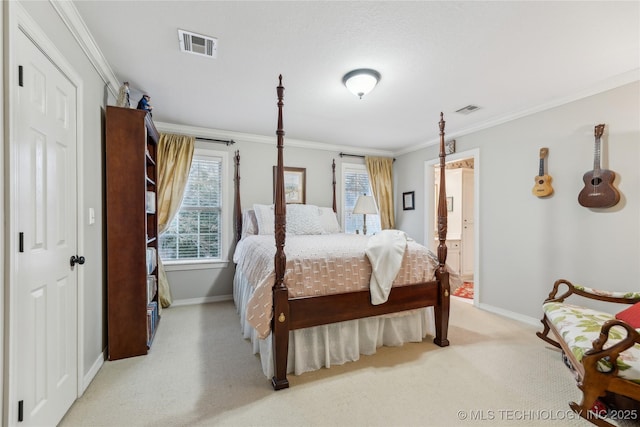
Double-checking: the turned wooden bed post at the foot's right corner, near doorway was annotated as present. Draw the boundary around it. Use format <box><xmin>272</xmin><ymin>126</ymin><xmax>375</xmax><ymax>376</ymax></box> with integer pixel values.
<box><xmin>433</xmin><ymin>113</ymin><xmax>450</xmax><ymax>347</ymax></box>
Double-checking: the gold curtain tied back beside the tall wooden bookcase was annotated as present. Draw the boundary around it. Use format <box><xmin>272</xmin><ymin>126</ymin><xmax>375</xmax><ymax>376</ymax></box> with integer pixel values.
<box><xmin>157</xmin><ymin>133</ymin><xmax>195</xmax><ymax>307</ymax></box>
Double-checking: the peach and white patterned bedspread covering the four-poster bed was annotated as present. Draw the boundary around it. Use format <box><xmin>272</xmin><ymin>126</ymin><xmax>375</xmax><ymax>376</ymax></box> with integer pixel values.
<box><xmin>234</xmin><ymin>234</ymin><xmax>460</xmax><ymax>338</ymax></box>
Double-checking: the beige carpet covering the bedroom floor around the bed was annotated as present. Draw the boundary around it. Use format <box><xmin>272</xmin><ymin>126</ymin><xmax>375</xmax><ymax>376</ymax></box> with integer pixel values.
<box><xmin>60</xmin><ymin>298</ymin><xmax>616</xmax><ymax>427</ymax></box>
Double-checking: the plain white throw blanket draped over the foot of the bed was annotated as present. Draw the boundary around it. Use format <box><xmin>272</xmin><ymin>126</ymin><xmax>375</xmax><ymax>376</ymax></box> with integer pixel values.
<box><xmin>365</xmin><ymin>230</ymin><xmax>407</xmax><ymax>305</ymax></box>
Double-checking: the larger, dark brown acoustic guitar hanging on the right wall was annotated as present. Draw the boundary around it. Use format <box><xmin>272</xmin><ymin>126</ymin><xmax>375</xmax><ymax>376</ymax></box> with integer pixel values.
<box><xmin>578</xmin><ymin>125</ymin><xmax>620</xmax><ymax>208</ymax></box>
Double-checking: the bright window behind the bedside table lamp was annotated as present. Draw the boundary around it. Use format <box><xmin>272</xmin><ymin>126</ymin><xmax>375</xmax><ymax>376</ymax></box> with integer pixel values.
<box><xmin>342</xmin><ymin>163</ymin><xmax>381</xmax><ymax>235</ymax></box>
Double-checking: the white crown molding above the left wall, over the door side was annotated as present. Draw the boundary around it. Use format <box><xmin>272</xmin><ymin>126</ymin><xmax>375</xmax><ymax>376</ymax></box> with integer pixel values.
<box><xmin>49</xmin><ymin>0</ymin><xmax>120</xmax><ymax>98</ymax></box>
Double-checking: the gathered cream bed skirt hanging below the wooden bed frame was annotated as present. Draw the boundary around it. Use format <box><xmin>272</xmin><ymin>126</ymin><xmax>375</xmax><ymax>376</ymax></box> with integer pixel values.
<box><xmin>233</xmin><ymin>269</ymin><xmax>435</xmax><ymax>378</ymax></box>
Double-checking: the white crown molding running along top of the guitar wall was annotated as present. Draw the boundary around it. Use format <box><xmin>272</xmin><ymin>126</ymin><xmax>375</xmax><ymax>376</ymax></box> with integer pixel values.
<box><xmin>393</xmin><ymin>68</ymin><xmax>640</xmax><ymax>157</ymax></box>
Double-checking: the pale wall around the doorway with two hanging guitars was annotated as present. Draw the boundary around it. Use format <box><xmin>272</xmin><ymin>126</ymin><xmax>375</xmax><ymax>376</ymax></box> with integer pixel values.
<box><xmin>395</xmin><ymin>82</ymin><xmax>640</xmax><ymax>319</ymax></box>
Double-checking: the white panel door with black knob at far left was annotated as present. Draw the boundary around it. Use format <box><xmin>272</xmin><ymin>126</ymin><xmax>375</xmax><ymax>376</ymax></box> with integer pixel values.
<box><xmin>16</xmin><ymin>32</ymin><xmax>78</xmax><ymax>425</ymax></box>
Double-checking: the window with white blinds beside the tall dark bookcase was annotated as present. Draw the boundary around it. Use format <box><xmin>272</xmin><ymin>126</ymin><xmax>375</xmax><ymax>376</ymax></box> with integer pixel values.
<box><xmin>159</xmin><ymin>148</ymin><xmax>227</xmax><ymax>261</ymax></box>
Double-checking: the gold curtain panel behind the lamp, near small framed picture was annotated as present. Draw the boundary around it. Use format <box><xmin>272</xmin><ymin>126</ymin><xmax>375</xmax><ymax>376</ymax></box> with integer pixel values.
<box><xmin>365</xmin><ymin>156</ymin><xmax>396</xmax><ymax>230</ymax></box>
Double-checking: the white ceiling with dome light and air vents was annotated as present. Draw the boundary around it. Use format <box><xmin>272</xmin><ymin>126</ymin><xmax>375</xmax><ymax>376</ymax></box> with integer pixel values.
<box><xmin>74</xmin><ymin>1</ymin><xmax>640</xmax><ymax>153</ymax></box>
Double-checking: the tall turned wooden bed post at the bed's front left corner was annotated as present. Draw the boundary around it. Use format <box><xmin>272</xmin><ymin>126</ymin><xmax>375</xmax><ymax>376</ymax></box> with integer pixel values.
<box><xmin>271</xmin><ymin>75</ymin><xmax>289</xmax><ymax>390</ymax></box>
